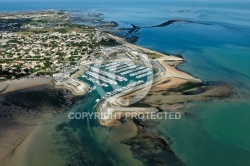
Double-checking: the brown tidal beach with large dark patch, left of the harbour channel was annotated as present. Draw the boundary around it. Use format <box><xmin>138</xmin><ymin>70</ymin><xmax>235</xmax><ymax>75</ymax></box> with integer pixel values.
<box><xmin>0</xmin><ymin>85</ymin><xmax>79</xmax><ymax>165</ymax></box>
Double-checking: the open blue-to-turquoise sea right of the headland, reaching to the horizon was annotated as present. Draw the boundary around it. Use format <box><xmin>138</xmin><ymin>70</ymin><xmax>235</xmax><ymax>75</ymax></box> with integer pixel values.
<box><xmin>0</xmin><ymin>1</ymin><xmax>250</xmax><ymax>166</ymax></box>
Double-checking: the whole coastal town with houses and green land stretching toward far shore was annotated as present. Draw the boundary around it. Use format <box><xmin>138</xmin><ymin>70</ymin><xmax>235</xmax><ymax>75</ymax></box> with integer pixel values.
<box><xmin>0</xmin><ymin>12</ymin><xmax>122</xmax><ymax>80</ymax></box>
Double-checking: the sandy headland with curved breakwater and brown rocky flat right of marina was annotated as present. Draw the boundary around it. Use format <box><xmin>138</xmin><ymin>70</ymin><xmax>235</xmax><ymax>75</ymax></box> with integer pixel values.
<box><xmin>96</xmin><ymin>34</ymin><xmax>231</xmax><ymax>127</ymax></box>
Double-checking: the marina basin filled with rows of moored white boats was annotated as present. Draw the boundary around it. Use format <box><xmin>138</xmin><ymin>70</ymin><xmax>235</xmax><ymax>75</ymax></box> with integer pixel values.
<box><xmin>81</xmin><ymin>62</ymin><xmax>154</xmax><ymax>94</ymax></box>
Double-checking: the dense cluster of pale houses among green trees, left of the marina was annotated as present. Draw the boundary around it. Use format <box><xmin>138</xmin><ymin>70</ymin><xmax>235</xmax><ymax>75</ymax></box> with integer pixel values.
<box><xmin>0</xmin><ymin>32</ymin><xmax>94</xmax><ymax>80</ymax></box>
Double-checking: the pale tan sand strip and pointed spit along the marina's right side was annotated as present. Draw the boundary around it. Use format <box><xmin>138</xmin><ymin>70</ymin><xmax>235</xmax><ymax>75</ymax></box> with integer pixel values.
<box><xmin>97</xmin><ymin>39</ymin><xmax>202</xmax><ymax>126</ymax></box>
